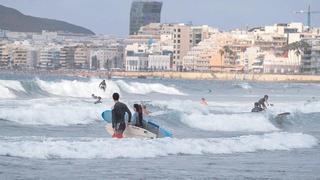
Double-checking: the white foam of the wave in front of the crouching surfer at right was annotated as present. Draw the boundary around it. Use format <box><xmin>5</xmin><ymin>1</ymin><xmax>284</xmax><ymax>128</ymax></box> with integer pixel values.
<box><xmin>181</xmin><ymin>113</ymin><xmax>278</xmax><ymax>132</ymax></box>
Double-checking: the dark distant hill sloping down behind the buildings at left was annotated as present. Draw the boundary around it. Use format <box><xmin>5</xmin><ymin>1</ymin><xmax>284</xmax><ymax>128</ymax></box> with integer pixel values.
<box><xmin>0</xmin><ymin>5</ymin><xmax>94</xmax><ymax>34</ymax></box>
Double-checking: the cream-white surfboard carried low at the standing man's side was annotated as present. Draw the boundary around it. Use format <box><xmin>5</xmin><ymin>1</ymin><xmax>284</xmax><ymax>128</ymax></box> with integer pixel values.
<box><xmin>105</xmin><ymin>123</ymin><xmax>157</xmax><ymax>139</ymax></box>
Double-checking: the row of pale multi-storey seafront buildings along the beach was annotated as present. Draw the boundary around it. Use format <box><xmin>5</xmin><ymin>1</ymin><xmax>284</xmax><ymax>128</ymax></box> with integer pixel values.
<box><xmin>0</xmin><ymin>22</ymin><xmax>320</xmax><ymax>74</ymax></box>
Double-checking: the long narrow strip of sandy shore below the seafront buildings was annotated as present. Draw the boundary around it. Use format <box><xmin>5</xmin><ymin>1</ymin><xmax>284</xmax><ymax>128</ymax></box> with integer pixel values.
<box><xmin>0</xmin><ymin>69</ymin><xmax>320</xmax><ymax>82</ymax></box>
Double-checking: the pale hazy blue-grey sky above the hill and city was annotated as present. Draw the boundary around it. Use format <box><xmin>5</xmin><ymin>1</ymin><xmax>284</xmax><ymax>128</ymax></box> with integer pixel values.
<box><xmin>0</xmin><ymin>0</ymin><xmax>320</xmax><ymax>36</ymax></box>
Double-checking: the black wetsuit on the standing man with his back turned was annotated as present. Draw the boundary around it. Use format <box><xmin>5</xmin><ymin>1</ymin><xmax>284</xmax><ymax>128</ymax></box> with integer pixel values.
<box><xmin>112</xmin><ymin>102</ymin><xmax>131</xmax><ymax>132</ymax></box>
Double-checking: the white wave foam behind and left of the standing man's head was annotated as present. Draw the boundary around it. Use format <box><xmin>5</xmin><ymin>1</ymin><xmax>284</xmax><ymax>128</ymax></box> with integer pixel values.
<box><xmin>36</xmin><ymin>79</ymin><xmax>120</xmax><ymax>97</ymax></box>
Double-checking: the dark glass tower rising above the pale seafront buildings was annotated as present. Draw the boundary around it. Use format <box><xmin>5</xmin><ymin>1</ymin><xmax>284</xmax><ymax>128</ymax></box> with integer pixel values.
<box><xmin>130</xmin><ymin>1</ymin><xmax>162</xmax><ymax>35</ymax></box>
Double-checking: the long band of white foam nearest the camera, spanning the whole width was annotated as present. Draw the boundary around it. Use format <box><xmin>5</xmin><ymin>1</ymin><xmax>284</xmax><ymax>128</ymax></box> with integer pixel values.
<box><xmin>0</xmin><ymin>132</ymin><xmax>318</xmax><ymax>159</ymax></box>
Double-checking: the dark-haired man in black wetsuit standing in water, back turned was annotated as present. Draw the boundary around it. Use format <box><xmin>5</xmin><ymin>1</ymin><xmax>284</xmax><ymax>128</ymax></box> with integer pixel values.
<box><xmin>112</xmin><ymin>93</ymin><xmax>131</xmax><ymax>138</ymax></box>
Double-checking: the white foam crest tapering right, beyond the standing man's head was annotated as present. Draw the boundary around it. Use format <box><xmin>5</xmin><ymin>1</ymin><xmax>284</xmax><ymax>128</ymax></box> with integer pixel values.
<box><xmin>116</xmin><ymin>80</ymin><xmax>185</xmax><ymax>95</ymax></box>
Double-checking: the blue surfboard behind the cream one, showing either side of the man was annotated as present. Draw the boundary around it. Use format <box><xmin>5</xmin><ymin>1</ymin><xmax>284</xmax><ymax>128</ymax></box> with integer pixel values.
<box><xmin>101</xmin><ymin>109</ymin><xmax>173</xmax><ymax>138</ymax></box>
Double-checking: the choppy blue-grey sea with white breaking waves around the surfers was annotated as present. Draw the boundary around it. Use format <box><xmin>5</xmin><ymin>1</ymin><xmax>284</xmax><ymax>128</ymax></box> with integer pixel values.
<box><xmin>0</xmin><ymin>75</ymin><xmax>320</xmax><ymax>179</ymax></box>
